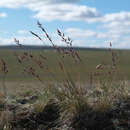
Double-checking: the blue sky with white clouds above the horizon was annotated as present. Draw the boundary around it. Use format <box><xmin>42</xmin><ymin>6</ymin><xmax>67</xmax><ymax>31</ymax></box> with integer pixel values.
<box><xmin>0</xmin><ymin>0</ymin><xmax>130</xmax><ymax>49</ymax></box>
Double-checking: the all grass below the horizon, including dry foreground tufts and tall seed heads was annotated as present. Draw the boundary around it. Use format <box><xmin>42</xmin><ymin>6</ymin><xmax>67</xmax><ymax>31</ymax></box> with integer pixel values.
<box><xmin>0</xmin><ymin>22</ymin><xmax>130</xmax><ymax>130</ymax></box>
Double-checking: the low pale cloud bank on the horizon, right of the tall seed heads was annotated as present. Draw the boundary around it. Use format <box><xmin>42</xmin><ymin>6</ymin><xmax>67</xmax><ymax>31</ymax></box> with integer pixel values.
<box><xmin>65</xmin><ymin>28</ymin><xmax>130</xmax><ymax>48</ymax></box>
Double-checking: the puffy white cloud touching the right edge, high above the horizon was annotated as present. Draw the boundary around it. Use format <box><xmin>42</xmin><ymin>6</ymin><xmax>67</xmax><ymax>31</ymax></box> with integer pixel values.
<box><xmin>102</xmin><ymin>12</ymin><xmax>130</xmax><ymax>35</ymax></box>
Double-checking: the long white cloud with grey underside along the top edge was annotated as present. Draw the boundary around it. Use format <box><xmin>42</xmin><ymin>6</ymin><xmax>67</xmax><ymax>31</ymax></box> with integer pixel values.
<box><xmin>0</xmin><ymin>0</ymin><xmax>101</xmax><ymax>22</ymax></box>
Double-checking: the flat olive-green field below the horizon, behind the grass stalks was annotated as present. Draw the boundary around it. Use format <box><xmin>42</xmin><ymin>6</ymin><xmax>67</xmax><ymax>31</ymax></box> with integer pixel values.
<box><xmin>0</xmin><ymin>50</ymin><xmax>130</xmax><ymax>81</ymax></box>
